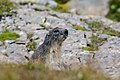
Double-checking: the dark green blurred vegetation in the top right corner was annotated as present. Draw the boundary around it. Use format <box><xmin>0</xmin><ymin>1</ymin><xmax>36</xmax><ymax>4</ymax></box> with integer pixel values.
<box><xmin>107</xmin><ymin>0</ymin><xmax>120</xmax><ymax>21</ymax></box>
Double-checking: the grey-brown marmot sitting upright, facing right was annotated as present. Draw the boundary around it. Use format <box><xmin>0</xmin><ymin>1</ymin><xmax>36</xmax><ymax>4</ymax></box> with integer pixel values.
<box><xmin>31</xmin><ymin>27</ymin><xmax>68</xmax><ymax>63</ymax></box>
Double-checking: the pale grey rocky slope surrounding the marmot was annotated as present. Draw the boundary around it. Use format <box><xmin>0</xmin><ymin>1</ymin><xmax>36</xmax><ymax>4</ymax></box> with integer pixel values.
<box><xmin>0</xmin><ymin>0</ymin><xmax>120</xmax><ymax>78</ymax></box>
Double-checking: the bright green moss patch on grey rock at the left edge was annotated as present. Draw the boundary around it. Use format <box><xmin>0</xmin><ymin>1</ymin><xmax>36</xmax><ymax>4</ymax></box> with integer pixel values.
<box><xmin>0</xmin><ymin>31</ymin><xmax>20</xmax><ymax>41</ymax></box>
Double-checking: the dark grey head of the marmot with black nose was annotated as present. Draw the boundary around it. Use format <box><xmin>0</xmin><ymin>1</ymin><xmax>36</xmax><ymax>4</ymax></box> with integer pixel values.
<box><xmin>44</xmin><ymin>27</ymin><xmax>68</xmax><ymax>45</ymax></box>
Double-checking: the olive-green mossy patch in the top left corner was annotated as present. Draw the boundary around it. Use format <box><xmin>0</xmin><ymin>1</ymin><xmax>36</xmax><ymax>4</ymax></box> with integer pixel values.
<box><xmin>0</xmin><ymin>0</ymin><xmax>14</xmax><ymax>15</ymax></box>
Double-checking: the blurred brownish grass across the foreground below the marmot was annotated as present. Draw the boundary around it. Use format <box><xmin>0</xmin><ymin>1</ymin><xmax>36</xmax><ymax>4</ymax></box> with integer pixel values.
<box><xmin>0</xmin><ymin>63</ymin><xmax>110</xmax><ymax>80</ymax></box>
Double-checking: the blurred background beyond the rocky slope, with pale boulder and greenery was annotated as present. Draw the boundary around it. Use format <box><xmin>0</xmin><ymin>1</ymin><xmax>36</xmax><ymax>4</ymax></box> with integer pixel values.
<box><xmin>7</xmin><ymin>0</ymin><xmax>120</xmax><ymax>21</ymax></box>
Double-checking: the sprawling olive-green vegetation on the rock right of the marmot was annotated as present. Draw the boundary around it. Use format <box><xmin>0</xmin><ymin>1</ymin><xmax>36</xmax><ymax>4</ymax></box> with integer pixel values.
<box><xmin>79</xmin><ymin>20</ymin><xmax>120</xmax><ymax>51</ymax></box>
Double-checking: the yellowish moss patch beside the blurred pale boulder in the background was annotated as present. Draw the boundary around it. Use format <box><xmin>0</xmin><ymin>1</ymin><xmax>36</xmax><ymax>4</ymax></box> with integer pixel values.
<box><xmin>52</xmin><ymin>4</ymin><xmax>71</xmax><ymax>12</ymax></box>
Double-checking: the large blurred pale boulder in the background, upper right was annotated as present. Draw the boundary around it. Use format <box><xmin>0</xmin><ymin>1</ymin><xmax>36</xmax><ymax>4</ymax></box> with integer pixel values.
<box><xmin>68</xmin><ymin>0</ymin><xmax>109</xmax><ymax>16</ymax></box>
